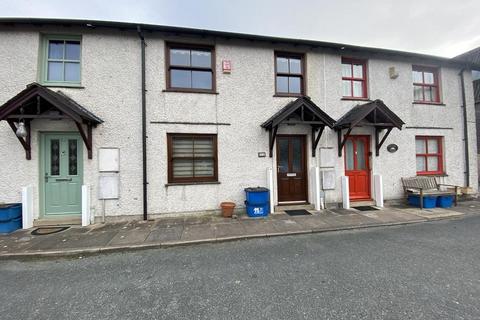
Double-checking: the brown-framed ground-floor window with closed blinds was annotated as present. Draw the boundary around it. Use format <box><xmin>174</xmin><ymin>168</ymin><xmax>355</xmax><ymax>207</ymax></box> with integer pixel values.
<box><xmin>167</xmin><ymin>133</ymin><xmax>217</xmax><ymax>183</ymax></box>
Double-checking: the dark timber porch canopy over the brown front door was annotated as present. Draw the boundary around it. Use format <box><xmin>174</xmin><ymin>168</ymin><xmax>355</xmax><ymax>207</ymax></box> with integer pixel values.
<box><xmin>261</xmin><ymin>96</ymin><xmax>335</xmax><ymax>157</ymax></box>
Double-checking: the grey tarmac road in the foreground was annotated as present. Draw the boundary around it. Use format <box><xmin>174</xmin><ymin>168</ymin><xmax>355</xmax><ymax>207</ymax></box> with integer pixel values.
<box><xmin>0</xmin><ymin>211</ymin><xmax>480</xmax><ymax>320</ymax></box>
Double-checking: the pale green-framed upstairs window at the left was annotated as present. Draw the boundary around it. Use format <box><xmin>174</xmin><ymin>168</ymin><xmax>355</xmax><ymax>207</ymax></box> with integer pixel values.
<box><xmin>41</xmin><ymin>36</ymin><xmax>81</xmax><ymax>86</ymax></box>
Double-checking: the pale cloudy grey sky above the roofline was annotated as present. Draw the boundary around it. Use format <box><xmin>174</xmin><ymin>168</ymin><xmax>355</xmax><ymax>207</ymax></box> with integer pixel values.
<box><xmin>0</xmin><ymin>0</ymin><xmax>480</xmax><ymax>57</ymax></box>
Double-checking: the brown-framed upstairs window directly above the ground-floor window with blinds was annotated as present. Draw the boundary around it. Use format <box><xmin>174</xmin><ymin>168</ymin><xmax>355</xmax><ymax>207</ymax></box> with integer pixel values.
<box><xmin>167</xmin><ymin>44</ymin><xmax>215</xmax><ymax>92</ymax></box>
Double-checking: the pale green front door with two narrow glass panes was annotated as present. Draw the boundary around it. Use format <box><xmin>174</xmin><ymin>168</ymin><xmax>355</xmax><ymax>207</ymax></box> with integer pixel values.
<box><xmin>40</xmin><ymin>133</ymin><xmax>83</xmax><ymax>216</ymax></box>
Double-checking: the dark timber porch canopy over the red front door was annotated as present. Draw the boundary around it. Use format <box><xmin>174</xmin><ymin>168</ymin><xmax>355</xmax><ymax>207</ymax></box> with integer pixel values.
<box><xmin>335</xmin><ymin>99</ymin><xmax>405</xmax><ymax>157</ymax></box>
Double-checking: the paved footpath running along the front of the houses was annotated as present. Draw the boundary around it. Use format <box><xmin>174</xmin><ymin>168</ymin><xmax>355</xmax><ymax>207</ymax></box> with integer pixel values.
<box><xmin>0</xmin><ymin>200</ymin><xmax>480</xmax><ymax>258</ymax></box>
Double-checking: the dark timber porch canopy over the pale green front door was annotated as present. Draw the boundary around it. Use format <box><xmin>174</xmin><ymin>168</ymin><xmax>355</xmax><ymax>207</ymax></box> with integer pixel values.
<box><xmin>0</xmin><ymin>82</ymin><xmax>103</xmax><ymax>160</ymax></box>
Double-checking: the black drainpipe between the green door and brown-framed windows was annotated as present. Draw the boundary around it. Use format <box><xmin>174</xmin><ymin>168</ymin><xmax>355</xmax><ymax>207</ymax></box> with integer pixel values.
<box><xmin>137</xmin><ymin>26</ymin><xmax>148</xmax><ymax>220</ymax></box>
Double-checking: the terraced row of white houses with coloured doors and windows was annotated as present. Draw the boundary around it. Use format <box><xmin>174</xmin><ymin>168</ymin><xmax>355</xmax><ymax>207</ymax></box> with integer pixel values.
<box><xmin>0</xmin><ymin>18</ymin><xmax>479</xmax><ymax>228</ymax></box>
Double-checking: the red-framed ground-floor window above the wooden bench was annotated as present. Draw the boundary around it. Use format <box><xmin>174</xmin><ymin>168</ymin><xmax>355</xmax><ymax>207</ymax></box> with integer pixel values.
<box><xmin>415</xmin><ymin>136</ymin><xmax>444</xmax><ymax>175</ymax></box>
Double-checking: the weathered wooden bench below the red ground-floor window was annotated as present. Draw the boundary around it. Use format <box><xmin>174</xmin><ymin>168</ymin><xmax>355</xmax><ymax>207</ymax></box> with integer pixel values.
<box><xmin>402</xmin><ymin>177</ymin><xmax>460</xmax><ymax>209</ymax></box>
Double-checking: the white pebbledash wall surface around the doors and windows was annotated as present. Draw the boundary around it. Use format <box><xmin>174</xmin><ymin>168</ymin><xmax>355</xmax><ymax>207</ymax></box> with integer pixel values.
<box><xmin>0</xmin><ymin>27</ymin><xmax>477</xmax><ymax>220</ymax></box>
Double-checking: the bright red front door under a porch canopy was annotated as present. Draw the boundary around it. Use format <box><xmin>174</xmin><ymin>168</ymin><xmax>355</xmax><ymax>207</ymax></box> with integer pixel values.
<box><xmin>345</xmin><ymin>136</ymin><xmax>371</xmax><ymax>200</ymax></box>
